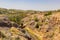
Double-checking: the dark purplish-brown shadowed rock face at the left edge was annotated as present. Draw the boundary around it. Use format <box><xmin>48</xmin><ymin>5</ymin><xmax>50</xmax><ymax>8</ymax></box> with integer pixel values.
<box><xmin>0</xmin><ymin>19</ymin><xmax>19</xmax><ymax>28</ymax></box>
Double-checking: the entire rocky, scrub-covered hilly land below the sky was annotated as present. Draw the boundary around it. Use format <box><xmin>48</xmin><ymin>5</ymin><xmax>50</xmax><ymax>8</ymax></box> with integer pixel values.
<box><xmin>0</xmin><ymin>8</ymin><xmax>60</xmax><ymax>40</ymax></box>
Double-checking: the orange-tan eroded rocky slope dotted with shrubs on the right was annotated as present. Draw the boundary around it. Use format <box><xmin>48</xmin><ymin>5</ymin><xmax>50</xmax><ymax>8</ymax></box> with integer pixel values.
<box><xmin>23</xmin><ymin>12</ymin><xmax>60</xmax><ymax>40</ymax></box>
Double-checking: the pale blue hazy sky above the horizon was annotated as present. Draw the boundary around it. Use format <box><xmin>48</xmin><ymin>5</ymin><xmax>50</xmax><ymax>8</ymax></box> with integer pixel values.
<box><xmin>0</xmin><ymin>0</ymin><xmax>60</xmax><ymax>10</ymax></box>
